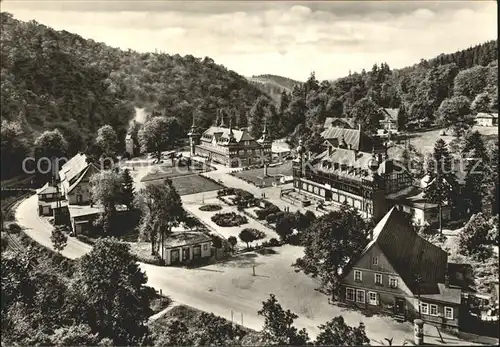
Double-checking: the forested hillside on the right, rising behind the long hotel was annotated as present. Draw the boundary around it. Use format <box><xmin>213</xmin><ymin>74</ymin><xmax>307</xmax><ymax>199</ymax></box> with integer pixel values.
<box><xmin>277</xmin><ymin>41</ymin><xmax>498</xmax><ymax>148</ymax></box>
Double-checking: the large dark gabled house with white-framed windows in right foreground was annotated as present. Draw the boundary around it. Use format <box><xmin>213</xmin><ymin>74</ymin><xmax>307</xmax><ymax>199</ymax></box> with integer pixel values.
<box><xmin>340</xmin><ymin>207</ymin><xmax>463</xmax><ymax>330</ymax></box>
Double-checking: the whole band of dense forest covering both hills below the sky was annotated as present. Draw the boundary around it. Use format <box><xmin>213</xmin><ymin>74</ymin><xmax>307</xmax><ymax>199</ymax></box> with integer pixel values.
<box><xmin>0</xmin><ymin>13</ymin><xmax>498</xmax><ymax>178</ymax></box>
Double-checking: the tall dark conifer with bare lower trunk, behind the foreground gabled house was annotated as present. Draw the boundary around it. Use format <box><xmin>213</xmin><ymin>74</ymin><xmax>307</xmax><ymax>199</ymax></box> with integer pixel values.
<box><xmin>424</xmin><ymin>139</ymin><xmax>457</xmax><ymax>234</ymax></box>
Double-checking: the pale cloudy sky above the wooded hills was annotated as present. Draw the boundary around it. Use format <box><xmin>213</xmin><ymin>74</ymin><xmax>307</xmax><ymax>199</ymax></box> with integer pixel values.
<box><xmin>1</xmin><ymin>0</ymin><xmax>497</xmax><ymax>81</ymax></box>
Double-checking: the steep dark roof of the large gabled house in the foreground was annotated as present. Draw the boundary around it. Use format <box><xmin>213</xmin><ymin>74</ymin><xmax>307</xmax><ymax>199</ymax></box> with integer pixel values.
<box><xmin>363</xmin><ymin>207</ymin><xmax>448</xmax><ymax>294</ymax></box>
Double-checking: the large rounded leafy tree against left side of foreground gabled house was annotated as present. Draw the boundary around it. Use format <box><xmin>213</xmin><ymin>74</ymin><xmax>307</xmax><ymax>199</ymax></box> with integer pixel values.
<box><xmin>294</xmin><ymin>204</ymin><xmax>368</xmax><ymax>297</ymax></box>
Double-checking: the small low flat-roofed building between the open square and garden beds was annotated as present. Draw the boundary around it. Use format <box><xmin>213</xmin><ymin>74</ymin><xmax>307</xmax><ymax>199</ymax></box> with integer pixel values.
<box><xmin>163</xmin><ymin>231</ymin><xmax>212</xmax><ymax>265</ymax></box>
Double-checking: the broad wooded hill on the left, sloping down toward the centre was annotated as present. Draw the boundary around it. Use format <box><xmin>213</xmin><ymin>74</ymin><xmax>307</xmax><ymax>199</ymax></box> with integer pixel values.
<box><xmin>0</xmin><ymin>12</ymin><xmax>269</xmax><ymax>148</ymax></box>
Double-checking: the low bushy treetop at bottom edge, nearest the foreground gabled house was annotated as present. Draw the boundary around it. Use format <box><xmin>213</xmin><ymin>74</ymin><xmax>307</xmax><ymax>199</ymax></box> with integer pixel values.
<box><xmin>315</xmin><ymin>316</ymin><xmax>370</xmax><ymax>346</ymax></box>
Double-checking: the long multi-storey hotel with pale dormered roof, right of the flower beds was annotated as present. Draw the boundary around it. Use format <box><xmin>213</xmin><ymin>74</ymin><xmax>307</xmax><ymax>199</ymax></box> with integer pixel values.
<box><xmin>293</xmin><ymin>127</ymin><xmax>413</xmax><ymax>220</ymax></box>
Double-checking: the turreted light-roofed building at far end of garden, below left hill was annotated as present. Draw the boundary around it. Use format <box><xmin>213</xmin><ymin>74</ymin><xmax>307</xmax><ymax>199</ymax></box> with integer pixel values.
<box><xmin>188</xmin><ymin>113</ymin><xmax>272</xmax><ymax>167</ymax></box>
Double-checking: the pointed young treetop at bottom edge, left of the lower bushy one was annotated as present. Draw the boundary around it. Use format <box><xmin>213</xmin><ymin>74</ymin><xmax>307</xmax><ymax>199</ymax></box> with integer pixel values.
<box><xmin>257</xmin><ymin>294</ymin><xmax>309</xmax><ymax>345</ymax></box>
